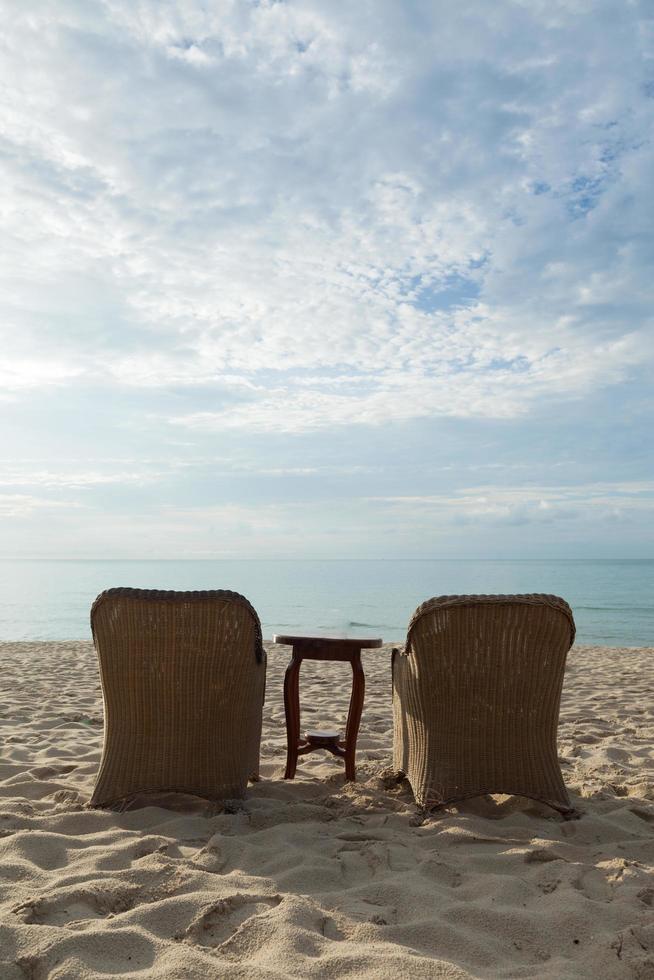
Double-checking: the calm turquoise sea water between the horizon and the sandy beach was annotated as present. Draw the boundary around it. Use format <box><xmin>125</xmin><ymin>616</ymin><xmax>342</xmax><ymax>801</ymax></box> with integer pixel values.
<box><xmin>0</xmin><ymin>559</ymin><xmax>654</xmax><ymax>646</ymax></box>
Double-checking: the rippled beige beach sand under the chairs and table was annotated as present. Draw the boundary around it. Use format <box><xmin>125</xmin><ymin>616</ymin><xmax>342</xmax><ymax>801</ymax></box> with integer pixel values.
<box><xmin>0</xmin><ymin>642</ymin><xmax>654</xmax><ymax>980</ymax></box>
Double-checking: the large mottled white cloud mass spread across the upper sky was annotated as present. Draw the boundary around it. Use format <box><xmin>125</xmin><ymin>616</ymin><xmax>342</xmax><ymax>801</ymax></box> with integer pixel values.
<box><xmin>3</xmin><ymin>2</ymin><xmax>652</xmax><ymax>431</ymax></box>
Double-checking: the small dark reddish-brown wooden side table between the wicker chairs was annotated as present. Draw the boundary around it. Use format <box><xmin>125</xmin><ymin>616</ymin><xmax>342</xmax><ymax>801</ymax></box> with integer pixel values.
<box><xmin>273</xmin><ymin>634</ymin><xmax>382</xmax><ymax>781</ymax></box>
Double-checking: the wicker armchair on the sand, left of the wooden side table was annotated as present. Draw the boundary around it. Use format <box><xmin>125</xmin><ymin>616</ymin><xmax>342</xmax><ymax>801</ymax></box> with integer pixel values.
<box><xmin>89</xmin><ymin>589</ymin><xmax>266</xmax><ymax>808</ymax></box>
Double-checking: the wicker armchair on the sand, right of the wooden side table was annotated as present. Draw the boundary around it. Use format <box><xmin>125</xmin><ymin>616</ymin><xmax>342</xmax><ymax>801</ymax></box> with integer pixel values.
<box><xmin>393</xmin><ymin>595</ymin><xmax>575</xmax><ymax>816</ymax></box>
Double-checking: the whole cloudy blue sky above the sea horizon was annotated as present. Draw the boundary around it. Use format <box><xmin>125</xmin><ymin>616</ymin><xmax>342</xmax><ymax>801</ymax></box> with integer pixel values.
<box><xmin>0</xmin><ymin>0</ymin><xmax>654</xmax><ymax>558</ymax></box>
